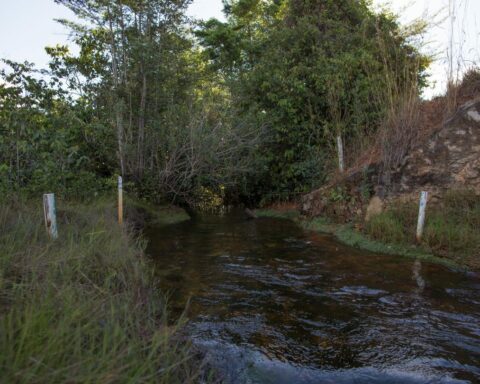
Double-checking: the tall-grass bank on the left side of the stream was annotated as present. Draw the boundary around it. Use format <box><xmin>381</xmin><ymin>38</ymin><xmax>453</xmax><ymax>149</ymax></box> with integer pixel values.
<box><xmin>0</xmin><ymin>203</ymin><xmax>206</xmax><ymax>383</ymax></box>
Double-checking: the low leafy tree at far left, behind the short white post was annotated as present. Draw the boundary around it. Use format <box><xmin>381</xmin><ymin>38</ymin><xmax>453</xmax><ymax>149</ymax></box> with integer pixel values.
<box><xmin>0</xmin><ymin>61</ymin><xmax>113</xmax><ymax>196</ymax></box>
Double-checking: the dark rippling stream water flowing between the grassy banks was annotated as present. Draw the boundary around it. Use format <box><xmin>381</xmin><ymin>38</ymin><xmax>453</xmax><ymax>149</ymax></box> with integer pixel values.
<box><xmin>147</xmin><ymin>213</ymin><xmax>480</xmax><ymax>384</ymax></box>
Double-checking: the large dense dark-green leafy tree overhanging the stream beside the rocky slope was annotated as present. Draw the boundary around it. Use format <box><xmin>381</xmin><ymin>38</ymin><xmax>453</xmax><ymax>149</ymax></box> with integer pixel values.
<box><xmin>198</xmin><ymin>0</ymin><xmax>427</xmax><ymax>204</ymax></box>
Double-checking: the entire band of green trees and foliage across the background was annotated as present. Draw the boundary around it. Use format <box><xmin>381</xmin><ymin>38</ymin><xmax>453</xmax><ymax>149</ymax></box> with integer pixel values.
<box><xmin>0</xmin><ymin>0</ymin><xmax>427</xmax><ymax>204</ymax></box>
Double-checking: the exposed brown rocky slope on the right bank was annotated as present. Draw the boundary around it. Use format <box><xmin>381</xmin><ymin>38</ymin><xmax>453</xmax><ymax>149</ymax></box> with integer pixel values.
<box><xmin>301</xmin><ymin>97</ymin><xmax>480</xmax><ymax>221</ymax></box>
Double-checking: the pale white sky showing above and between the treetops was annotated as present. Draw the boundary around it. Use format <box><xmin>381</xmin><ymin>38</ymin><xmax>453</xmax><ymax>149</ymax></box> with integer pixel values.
<box><xmin>0</xmin><ymin>0</ymin><xmax>480</xmax><ymax>98</ymax></box>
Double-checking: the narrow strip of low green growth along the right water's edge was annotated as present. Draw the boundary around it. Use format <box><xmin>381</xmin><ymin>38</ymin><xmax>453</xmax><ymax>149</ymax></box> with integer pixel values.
<box><xmin>255</xmin><ymin>207</ymin><xmax>467</xmax><ymax>270</ymax></box>
